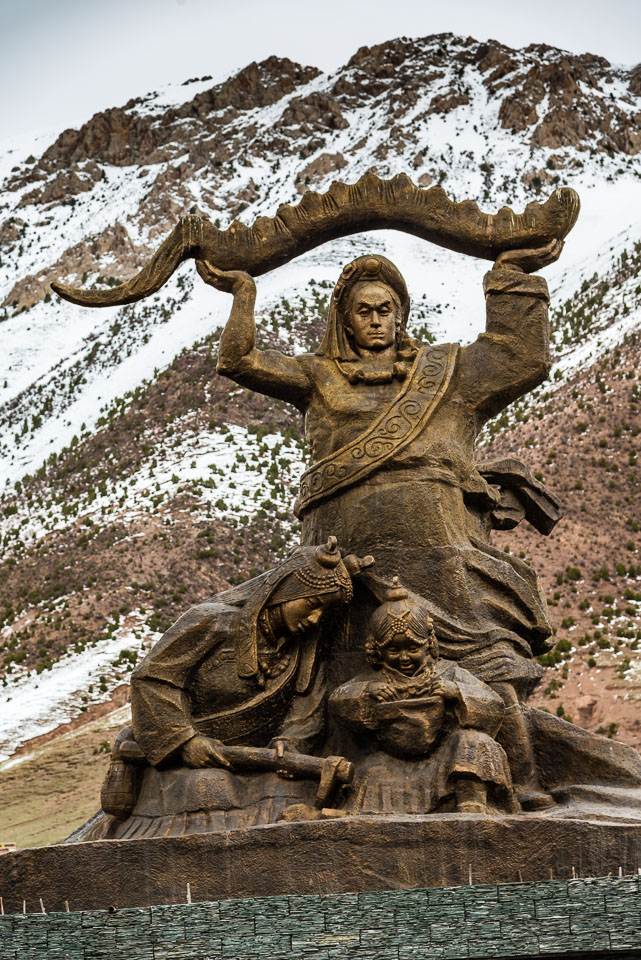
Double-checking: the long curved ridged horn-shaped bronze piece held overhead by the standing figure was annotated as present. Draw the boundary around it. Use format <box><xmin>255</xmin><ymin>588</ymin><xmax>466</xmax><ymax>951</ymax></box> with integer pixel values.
<box><xmin>51</xmin><ymin>173</ymin><xmax>579</xmax><ymax>307</ymax></box>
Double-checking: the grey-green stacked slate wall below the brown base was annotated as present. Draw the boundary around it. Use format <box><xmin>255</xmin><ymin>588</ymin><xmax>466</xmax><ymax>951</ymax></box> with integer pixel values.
<box><xmin>0</xmin><ymin>877</ymin><xmax>641</xmax><ymax>960</ymax></box>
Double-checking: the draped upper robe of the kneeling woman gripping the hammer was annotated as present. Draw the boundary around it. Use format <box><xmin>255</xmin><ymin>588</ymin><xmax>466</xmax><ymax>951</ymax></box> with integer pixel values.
<box><xmin>131</xmin><ymin>568</ymin><xmax>326</xmax><ymax>766</ymax></box>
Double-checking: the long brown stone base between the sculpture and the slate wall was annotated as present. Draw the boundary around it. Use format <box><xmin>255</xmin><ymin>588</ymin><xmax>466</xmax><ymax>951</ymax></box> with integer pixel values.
<box><xmin>0</xmin><ymin>808</ymin><xmax>641</xmax><ymax>914</ymax></box>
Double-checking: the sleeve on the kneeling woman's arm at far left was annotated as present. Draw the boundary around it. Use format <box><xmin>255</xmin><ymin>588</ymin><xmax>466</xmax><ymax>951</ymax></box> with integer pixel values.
<box><xmin>131</xmin><ymin>603</ymin><xmax>224</xmax><ymax>766</ymax></box>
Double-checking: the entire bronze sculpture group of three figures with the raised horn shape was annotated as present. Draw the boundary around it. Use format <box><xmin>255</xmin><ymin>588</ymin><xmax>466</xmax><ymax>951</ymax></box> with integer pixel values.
<box><xmin>54</xmin><ymin>174</ymin><xmax>641</xmax><ymax>856</ymax></box>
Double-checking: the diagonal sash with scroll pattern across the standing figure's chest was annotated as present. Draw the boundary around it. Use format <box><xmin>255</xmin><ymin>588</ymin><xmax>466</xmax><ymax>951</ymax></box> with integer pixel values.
<box><xmin>294</xmin><ymin>343</ymin><xmax>459</xmax><ymax>517</ymax></box>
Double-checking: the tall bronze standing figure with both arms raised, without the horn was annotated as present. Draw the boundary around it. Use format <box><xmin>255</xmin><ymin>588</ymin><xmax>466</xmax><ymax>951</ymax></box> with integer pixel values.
<box><xmin>198</xmin><ymin>241</ymin><xmax>562</xmax><ymax>806</ymax></box>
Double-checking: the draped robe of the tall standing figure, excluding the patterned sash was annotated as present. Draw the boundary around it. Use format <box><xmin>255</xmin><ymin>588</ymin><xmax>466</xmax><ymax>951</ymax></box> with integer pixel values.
<box><xmin>218</xmin><ymin>269</ymin><xmax>551</xmax><ymax>694</ymax></box>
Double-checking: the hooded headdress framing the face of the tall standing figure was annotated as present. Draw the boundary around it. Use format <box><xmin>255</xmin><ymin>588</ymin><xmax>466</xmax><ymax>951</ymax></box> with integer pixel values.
<box><xmin>316</xmin><ymin>253</ymin><xmax>416</xmax><ymax>374</ymax></box>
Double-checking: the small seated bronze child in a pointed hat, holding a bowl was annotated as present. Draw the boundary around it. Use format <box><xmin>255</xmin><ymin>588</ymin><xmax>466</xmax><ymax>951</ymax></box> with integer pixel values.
<box><xmin>329</xmin><ymin>577</ymin><xmax>518</xmax><ymax>814</ymax></box>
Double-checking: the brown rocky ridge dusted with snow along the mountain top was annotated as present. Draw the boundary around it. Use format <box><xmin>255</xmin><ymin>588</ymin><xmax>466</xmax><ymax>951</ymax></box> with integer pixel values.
<box><xmin>0</xmin><ymin>34</ymin><xmax>641</xmax><ymax>309</ymax></box>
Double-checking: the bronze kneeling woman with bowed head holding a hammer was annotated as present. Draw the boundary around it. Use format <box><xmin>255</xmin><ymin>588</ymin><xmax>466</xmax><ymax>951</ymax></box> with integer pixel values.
<box><xmin>77</xmin><ymin>537</ymin><xmax>374</xmax><ymax>839</ymax></box>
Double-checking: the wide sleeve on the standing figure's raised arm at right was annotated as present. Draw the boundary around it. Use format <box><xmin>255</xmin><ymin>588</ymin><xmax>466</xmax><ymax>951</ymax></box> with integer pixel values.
<box><xmin>459</xmin><ymin>269</ymin><xmax>551</xmax><ymax>423</ymax></box>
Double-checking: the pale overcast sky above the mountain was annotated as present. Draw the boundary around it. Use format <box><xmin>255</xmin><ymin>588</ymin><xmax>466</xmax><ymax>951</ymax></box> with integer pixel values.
<box><xmin>0</xmin><ymin>0</ymin><xmax>641</xmax><ymax>144</ymax></box>
